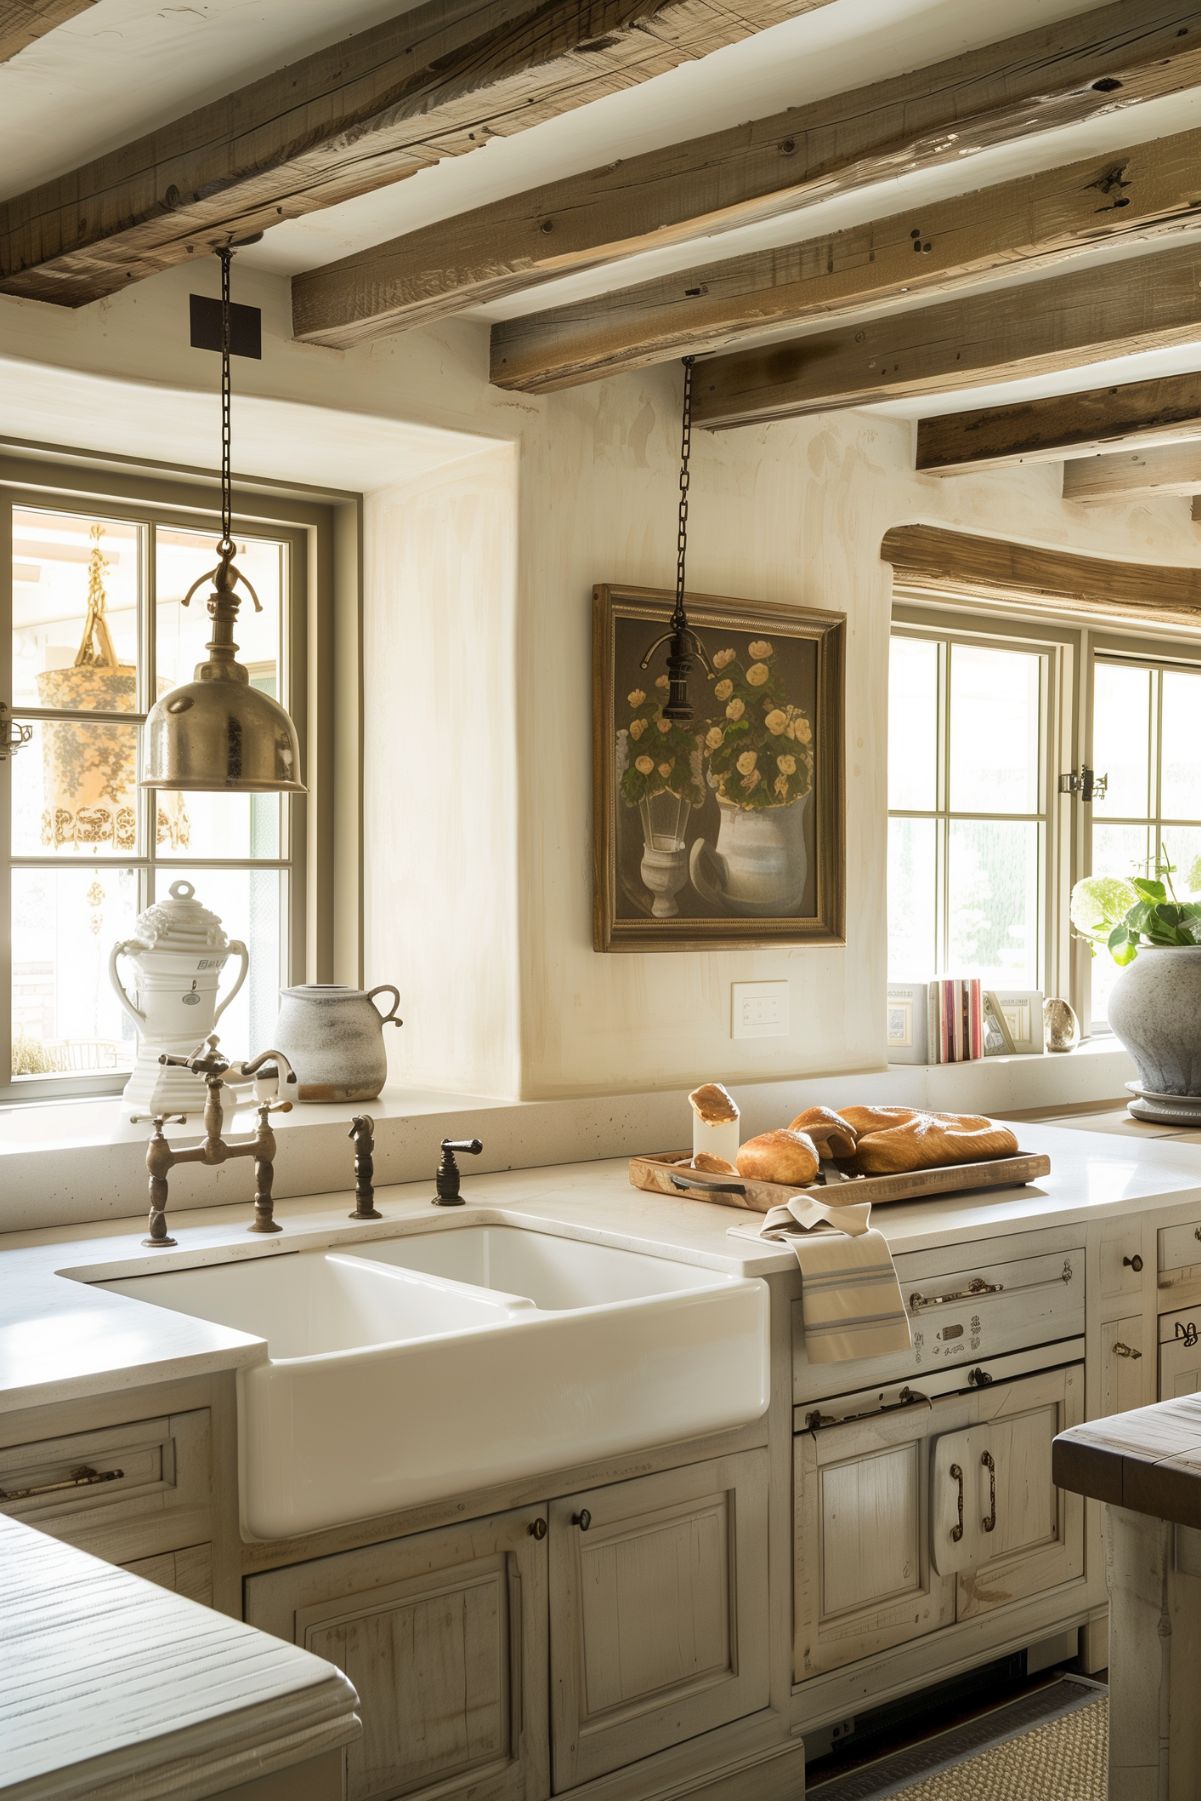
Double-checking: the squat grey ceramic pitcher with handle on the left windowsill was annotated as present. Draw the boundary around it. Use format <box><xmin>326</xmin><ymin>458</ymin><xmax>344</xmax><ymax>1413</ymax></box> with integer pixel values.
<box><xmin>274</xmin><ymin>982</ymin><xmax>403</xmax><ymax>1100</ymax></box>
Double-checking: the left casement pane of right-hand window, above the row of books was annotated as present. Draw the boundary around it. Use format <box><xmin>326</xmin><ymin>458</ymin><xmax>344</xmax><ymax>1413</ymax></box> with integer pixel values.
<box><xmin>888</xmin><ymin>625</ymin><xmax>1057</xmax><ymax>989</ymax></box>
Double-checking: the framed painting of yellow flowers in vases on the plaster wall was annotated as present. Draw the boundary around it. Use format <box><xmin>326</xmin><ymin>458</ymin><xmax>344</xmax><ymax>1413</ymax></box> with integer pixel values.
<box><xmin>592</xmin><ymin>585</ymin><xmax>846</xmax><ymax>951</ymax></box>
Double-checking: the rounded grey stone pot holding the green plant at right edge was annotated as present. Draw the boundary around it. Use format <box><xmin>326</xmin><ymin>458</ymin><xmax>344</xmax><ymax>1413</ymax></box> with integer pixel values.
<box><xmin>1109</xmin><ymin>944</ymin><xmax>1201</xmax><ymax>1100</ymax></box>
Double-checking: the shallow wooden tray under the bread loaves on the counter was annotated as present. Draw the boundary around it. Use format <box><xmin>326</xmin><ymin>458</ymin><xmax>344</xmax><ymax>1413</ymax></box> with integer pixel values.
<box><xmin>630</xmin><ymin>1151</ymin><xmax>1052</xmax><ymax>1214</ymax></box>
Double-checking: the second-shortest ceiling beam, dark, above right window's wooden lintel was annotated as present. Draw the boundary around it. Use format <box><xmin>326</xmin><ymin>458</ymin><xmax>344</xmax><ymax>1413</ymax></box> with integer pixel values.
<box><xmin>917</xmin><ymin>375</ymin><xmax>1201</xmax><ymax>475</ymax></box>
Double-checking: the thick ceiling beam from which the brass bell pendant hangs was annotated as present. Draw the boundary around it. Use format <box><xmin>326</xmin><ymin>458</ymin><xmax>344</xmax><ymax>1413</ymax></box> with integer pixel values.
<box><xmin>0</xmin><ymin>0</ymin><xmax>826</xmax><ymax>306</ymax></box>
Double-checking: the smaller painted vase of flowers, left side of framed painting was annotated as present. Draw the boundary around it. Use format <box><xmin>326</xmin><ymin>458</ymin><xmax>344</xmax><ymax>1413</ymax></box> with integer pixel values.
<box><xmin>619</xmin><ymin>675</ymin><xmax>704</xmax><ymax>919</ymax></box>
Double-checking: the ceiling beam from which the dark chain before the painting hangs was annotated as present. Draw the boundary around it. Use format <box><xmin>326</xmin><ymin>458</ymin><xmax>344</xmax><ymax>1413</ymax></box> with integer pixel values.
<box><xmin>492</xmin><ymin>131</ymin><xmax>1201</xmax><ymax>393</ymax></box>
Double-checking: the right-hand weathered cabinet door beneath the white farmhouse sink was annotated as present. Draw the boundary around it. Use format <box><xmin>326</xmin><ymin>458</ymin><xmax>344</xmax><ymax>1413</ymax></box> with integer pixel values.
<box><xmin>549</xmin><ymin>1450</ymin><xmax>769</xmax><ymax>1790</ymax></box>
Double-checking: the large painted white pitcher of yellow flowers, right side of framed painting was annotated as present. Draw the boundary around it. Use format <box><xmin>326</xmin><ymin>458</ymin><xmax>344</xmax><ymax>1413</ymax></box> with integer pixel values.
<box><xmin>691</xmin><ymin>638</ymin><xmax>814</xmax><ymax>917</ymax></box>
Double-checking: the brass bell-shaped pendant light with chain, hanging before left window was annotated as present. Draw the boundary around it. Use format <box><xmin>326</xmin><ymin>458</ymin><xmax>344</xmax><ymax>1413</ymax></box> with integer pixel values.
<box><xmin>140</xmin><ymin>245</ymin><xmax>306</xmax><ymax>794</ymax></box>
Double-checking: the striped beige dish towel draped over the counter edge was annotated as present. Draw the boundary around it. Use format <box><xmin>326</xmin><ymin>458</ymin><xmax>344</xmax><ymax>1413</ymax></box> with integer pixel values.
<box><xmin>731</xmin><ymin>1194</ymin><xmax>913</xmax><ymax>1363</ymax></box>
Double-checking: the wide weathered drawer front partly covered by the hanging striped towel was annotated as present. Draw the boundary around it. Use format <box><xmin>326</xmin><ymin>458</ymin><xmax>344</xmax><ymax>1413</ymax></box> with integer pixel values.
<box><xmin>792</xmin><ymin>1248</ymin><xmax>1084</xmax><ymax>1401</ymax></box>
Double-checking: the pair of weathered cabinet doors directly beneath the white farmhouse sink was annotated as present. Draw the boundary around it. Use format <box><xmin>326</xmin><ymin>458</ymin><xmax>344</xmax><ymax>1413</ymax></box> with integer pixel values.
<box><xmin>245</xmin><ymin>1450</ymin><xmax>769</xmax><ymax>1801</ymax></box>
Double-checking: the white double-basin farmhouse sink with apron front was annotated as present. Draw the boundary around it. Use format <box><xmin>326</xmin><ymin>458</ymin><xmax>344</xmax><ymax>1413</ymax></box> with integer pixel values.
<box><xmin>101</xmin><ymin>1221</ymin><xmax>767</xmax><ymax>1538</ymax></box>
